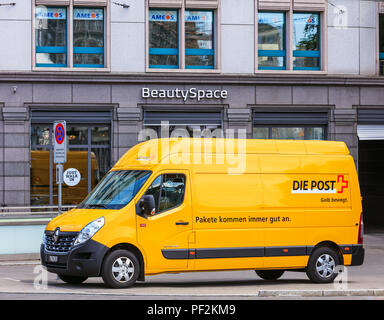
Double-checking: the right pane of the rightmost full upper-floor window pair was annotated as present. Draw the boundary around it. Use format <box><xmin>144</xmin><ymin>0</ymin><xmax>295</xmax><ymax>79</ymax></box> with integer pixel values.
<box><xmin>293</xmin><ymin>13</ymin><xmax>320</xmax><ymax>70</ymax></box>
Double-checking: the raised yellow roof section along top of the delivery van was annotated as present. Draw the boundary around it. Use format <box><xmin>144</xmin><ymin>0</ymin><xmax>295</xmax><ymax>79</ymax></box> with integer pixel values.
<box><xmin>114</xmin><ymin>138</ymin><xmax>349</xmax><ymax>168</ymax></box>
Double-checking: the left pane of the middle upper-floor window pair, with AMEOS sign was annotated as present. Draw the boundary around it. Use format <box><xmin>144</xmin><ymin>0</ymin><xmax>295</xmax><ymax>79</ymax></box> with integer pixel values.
<box><xmin>149</xmin><ymin>10</ymin><xmax>179</xmax><ymax>69</ymax></box>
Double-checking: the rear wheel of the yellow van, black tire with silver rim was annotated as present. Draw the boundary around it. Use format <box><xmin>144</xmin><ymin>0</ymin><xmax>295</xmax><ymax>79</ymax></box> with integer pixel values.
<box><xmin>306</xmin><ymin>247</ymin><xmax>340</xmax><ymax>283</ymax></box>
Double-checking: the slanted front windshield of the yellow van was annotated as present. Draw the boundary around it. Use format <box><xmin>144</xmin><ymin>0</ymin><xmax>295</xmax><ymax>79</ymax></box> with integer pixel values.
<box><xmin>78</xmin><ymin>170</ymin><xmax>152</xmax><ymax>210</ymax></box>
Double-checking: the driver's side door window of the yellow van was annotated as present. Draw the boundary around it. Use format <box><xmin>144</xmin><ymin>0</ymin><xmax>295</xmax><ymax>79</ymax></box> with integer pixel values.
<box><xmin>145</xmin><ymin>173</ymin><xmax>185</xmax><ymax>214</ymax></box>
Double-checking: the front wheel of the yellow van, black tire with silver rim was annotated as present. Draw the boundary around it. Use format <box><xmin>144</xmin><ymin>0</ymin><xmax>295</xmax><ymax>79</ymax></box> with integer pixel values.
<box><xmin>102</xmin><ymin>250</ymin><xmax>140</xmax><ymax>289</ymax></box>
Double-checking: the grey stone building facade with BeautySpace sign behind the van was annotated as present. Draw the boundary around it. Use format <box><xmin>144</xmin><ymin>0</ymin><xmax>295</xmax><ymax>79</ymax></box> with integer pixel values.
<box><xmin>0</xmin><ymin>0</ymin><xmax>384</xmax><ymax>224</ymax></box>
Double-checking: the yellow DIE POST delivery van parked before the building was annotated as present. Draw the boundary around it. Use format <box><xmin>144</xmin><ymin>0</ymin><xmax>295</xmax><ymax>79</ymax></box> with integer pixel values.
<box><xmin>41</xmin><ymin>138</ymin><xmax>364</xmax><ymax>288</ymax></box>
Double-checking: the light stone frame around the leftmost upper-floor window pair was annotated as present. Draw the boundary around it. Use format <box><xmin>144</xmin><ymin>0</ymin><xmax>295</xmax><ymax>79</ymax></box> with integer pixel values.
<box><xmin>31</xmin><ymin>0</ymin><xmax>111</xmax><ymax>72</ymax></box>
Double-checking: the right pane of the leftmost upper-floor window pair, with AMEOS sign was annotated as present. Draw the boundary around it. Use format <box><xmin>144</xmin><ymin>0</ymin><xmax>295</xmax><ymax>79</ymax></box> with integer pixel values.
<box><xmin>73</xmin><ymin>8</ymin><xmax>104</xmax><ymax>68</ymax></box>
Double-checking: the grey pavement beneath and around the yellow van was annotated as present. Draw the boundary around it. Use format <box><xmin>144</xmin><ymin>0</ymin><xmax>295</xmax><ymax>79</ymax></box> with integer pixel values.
<box><xmin>0</xmin><ymin>231</ymin><xmax>384</xmax><ymax>299</ymax></box>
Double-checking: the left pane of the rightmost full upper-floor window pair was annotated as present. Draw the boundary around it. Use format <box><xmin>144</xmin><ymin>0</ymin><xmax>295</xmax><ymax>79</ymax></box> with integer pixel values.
<box><xmin>258</xmin><ymin>12</ymin><xmax>286</xmax><ymax>70</ymax></box>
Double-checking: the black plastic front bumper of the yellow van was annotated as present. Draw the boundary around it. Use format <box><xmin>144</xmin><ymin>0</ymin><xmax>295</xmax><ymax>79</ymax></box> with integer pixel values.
<box><xmin>40</xmin><ymin>239</ymin><xmax>109</xmax><ymax>277</ymax></box>
